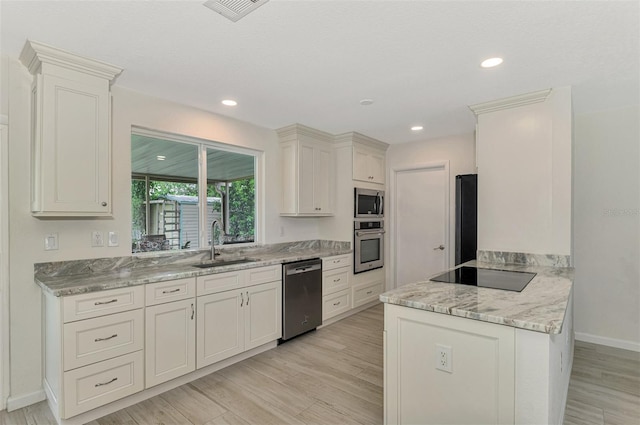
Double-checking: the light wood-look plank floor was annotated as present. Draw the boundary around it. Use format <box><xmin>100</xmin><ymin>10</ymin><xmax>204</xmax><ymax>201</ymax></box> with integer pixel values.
<box><xmin>0</xmin><ymin>304</ymin><xmax>640</xmax><ymax>425</ymax></box>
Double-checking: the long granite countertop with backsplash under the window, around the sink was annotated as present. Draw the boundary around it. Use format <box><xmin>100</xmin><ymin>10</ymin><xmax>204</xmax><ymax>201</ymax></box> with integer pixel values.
<box><xmin>34</xmin><ymin>243</ymin><xmax>352</xmax><ymax>297</ymax></box>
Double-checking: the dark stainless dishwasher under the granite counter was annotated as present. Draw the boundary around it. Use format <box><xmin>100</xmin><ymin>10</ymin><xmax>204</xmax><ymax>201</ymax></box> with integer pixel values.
<box><xmin>281</xmin><ymin>258</ymin><xmax>322</xmax><ymax>341</ymax></box>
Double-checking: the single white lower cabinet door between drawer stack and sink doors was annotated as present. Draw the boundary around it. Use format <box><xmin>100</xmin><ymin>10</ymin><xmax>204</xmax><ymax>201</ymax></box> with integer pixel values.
<box><xmin>145</xmin><ymin>299</ymin><xmax>196</xmax><ymax>388</ymax></box>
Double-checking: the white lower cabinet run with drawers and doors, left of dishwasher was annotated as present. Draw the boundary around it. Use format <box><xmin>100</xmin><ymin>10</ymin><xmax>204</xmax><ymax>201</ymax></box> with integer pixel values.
<box><xmin>43</xmin><ymin>264</ymin><xmax>282</xmax><ymax>423</ymax></box>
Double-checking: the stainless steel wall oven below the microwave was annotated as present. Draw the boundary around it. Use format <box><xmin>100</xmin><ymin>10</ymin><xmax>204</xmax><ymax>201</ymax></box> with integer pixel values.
<box><xmin>353</xmin><ymin>220</ymin><xmax>384</xmax><ymax>273</ymax></box>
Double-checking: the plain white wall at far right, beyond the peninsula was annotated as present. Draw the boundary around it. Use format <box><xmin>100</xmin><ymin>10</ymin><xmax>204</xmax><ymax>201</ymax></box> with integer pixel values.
<box><xmin>573</xmin><ymin>105</ymin><xmax>640</xmax><ymax>351</ymax></box>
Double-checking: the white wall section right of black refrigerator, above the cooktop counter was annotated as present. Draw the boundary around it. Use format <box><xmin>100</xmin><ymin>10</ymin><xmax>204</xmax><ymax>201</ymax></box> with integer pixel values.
<box><xmin>477</xmin><ymin>87</ymin><xmax>571</xmax><ymax>255</ymax></box>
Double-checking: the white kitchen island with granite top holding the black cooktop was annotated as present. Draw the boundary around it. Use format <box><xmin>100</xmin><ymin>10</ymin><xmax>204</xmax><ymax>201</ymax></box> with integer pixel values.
<box><xmin>380</xmin><ymin>261</ymin><xmax>573</xmax><ymax>424</ymax></box>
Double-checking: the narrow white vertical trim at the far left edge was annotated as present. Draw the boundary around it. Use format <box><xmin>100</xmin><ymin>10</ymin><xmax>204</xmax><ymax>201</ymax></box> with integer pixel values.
<box><xmin>0</xmin><ymin>125</ymin><xmax>11</xmax><ymax>410</ymax></box>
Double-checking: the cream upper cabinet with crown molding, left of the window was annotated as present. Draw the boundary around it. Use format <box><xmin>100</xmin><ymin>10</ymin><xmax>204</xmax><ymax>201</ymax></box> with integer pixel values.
<box><xmin>20</xmin><ymin>41</ymin><xmax>122</xmax><ymax>217</ymax></box>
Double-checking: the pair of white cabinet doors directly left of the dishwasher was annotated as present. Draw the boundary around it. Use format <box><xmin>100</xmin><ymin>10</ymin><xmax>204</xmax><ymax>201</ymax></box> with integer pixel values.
<box><xmin>196</xmin><ymin>281</ymin><xmax>282</xmax><ymax>368</ymax></box>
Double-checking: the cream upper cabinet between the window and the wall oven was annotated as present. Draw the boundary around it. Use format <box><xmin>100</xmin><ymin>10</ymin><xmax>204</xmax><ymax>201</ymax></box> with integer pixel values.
<box><xmin>278</xmin><ymin>124</ymin><xmax>335</xmax><ymax>216</ymax></box>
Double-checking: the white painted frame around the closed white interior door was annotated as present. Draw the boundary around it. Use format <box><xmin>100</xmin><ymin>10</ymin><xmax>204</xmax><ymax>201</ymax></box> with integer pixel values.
<box><xmin>385</xmin><ymin>160</ymin><xmax>452</xmax><ymax>290</ymax></box>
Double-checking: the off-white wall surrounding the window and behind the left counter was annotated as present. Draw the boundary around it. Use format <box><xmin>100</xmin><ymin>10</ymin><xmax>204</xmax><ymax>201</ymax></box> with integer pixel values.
<box><xmin>0</xmin><ymin>58</ymin><xmax>319</xmax><ymax>407</ymax></box>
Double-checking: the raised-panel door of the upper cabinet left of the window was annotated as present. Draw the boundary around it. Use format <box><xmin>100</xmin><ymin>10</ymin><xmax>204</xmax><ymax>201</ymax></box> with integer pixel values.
<box><xmin>37</xmin><ymin>75</ymin><xmax>111</xmax><ymax>215</ymax></box>
